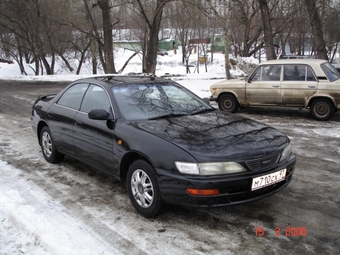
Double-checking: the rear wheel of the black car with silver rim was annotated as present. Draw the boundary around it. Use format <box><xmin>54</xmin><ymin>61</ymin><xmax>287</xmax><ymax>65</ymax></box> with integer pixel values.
<box><xmin>40</xmin><ymin>126</ymin><xmax>65</xmax><ymax>164</ymax></box>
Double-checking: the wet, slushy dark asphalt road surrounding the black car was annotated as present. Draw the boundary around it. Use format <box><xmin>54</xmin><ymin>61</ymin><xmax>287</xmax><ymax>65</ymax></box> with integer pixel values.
<box><xmin>0</xmin><ymin>80</ymin><xmax>340</xmax><ymax>255</ymax></box>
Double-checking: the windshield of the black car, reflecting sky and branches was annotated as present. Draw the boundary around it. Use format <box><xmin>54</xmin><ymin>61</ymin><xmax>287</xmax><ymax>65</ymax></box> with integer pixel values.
<box><xmin>112</xmin><ymin>82</ymin><xmax>214</xmax><ymax>120</ymax></box>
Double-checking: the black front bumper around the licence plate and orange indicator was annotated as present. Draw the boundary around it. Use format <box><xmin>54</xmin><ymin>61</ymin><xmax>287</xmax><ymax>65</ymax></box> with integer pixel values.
<box><xmin>157</xmin><ymin>154</ymin><xmax>296</xmax><ymax>208</ymax></box>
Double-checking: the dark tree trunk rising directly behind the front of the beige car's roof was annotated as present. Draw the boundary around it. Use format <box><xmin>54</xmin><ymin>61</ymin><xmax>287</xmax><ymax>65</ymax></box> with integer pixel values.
<box><xmin>258</xmin><ymin>0</ymin><xmax>276</xmax><ymax>60</ymax></box>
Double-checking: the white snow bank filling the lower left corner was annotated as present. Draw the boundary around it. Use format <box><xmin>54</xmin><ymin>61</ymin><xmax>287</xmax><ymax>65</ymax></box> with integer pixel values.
<box><xmin>0</xmin><ymin>160</ymin><xmax>114</xmax><ymax>254</ymax></box>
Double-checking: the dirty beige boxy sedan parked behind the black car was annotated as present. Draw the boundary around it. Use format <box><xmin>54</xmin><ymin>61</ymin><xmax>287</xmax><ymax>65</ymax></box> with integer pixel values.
<box><xmin>209</xmin><ymin>59</ymin><xmax>340</xmax><ymax>120</ymax></box>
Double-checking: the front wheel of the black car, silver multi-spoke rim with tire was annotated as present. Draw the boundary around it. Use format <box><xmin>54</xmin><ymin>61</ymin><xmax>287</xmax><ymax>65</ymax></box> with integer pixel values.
<box><xmin>126</xmin><ymin>160</ymin><xmax>163</xmax><ymax>217</ymax></box>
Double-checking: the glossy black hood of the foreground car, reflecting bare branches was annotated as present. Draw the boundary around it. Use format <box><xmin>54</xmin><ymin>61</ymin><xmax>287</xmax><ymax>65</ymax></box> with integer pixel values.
<box><xmin>133</xmin><ymin>111</ymin><xmax>289</xmax><ymax>162</ymax></box>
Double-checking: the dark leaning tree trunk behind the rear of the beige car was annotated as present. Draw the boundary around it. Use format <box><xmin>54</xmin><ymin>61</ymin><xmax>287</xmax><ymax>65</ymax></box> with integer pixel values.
<box><xmin>305</xmin><ymin>0</ymin><xmax>328</xmax><ymax>60</ymax></box>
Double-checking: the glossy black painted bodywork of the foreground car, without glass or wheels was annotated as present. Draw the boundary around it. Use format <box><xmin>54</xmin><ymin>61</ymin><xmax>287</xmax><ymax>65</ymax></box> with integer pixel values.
<box><xmin>31</xmin><ymin>77</ymin><xmax>296</xmax><ymax>213</ymax></box>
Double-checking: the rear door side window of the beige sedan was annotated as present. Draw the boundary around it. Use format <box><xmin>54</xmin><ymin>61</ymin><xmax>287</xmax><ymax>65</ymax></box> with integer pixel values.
<box><xmin>283</xmin><ymin>65</ymin><xmax>316</xmax><ymax>81</ymax></box>
